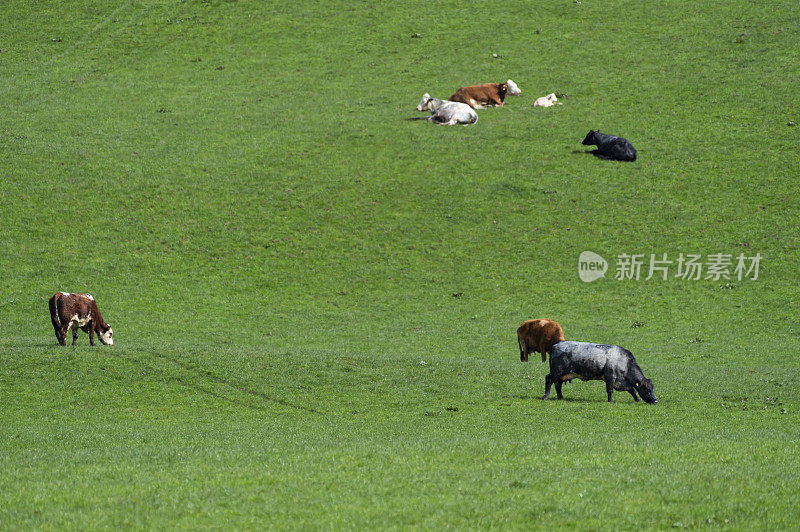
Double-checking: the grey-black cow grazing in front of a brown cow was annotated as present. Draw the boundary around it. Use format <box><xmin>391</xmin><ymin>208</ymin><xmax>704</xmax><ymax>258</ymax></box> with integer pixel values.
<box><xmin>542</xmin><ymin>342</ymin><xmax>658</xmax><ymax>404</ymax></box>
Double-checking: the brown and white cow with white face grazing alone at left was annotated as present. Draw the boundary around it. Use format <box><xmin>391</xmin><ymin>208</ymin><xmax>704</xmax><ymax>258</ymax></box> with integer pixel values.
<box><xmin>50</xmin><ymin>292</ymin><xmax>114</xmax><ymax>345</ymax></box>
